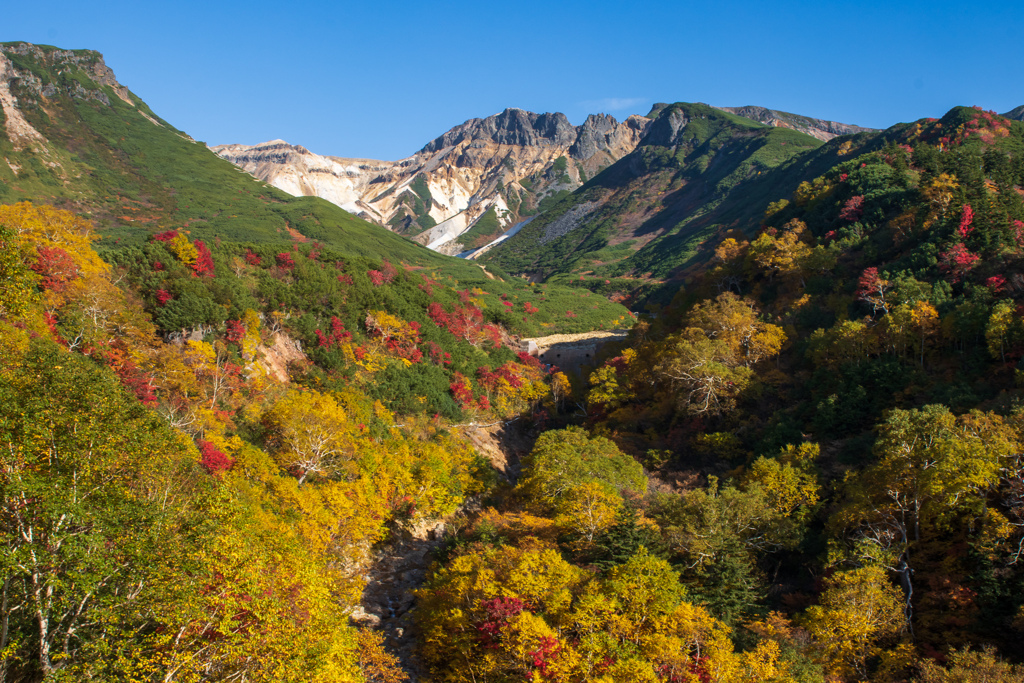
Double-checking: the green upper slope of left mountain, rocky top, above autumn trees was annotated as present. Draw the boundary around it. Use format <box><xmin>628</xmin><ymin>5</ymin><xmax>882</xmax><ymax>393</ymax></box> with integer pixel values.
<box><xmin>0</xmin><ymin>43</ymin><xmax>448</xmax><ymax>263</ymax></box>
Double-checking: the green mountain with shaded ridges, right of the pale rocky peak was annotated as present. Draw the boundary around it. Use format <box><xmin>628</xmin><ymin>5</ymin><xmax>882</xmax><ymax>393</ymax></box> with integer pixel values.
<box><xmin>481</xmin><ymin>102</ymin><xmax>851</xmax><ymax>289</ymax></box>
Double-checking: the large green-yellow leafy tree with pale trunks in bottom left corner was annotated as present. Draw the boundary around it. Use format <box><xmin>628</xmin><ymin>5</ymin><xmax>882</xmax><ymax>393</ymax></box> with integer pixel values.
<box><xmin>0</xmin><ymin>340</ymin><xmax>203</xmax><ymax>677</ymax></box>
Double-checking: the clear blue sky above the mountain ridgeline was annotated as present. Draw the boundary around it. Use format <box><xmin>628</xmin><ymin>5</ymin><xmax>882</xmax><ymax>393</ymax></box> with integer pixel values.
<box><xmin>0</xmin><ymin>0</ymin><xmax>1024</xmax><ymax>159</ymax></box>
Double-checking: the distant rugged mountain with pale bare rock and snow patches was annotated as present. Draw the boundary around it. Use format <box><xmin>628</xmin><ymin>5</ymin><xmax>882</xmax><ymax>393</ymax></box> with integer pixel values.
<box><xmin>213</xmin><ymin>109</ymin><xmax>650</xmax><ymax>254</ymax></box>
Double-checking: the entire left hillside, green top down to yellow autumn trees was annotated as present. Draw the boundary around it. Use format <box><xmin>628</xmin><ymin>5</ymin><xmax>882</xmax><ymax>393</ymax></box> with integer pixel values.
<box><xmin>0</xmin><ymin>43</ymin><xmax>632</xmax><ymax>681</ymax></box>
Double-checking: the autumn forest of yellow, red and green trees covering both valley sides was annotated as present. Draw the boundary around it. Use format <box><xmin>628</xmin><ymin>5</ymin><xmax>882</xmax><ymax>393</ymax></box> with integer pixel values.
<box><xmin>6</xmin><ymin>45</ymin><xmax>1024</xmax><ymax>683</ymax></box>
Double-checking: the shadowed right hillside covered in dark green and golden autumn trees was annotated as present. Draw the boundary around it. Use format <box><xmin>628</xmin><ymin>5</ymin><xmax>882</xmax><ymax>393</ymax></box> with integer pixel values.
<box><xmin>411</xmin><ymin>108</ymin><xmax>1024</xmax><ymax>683</ymax></box>
